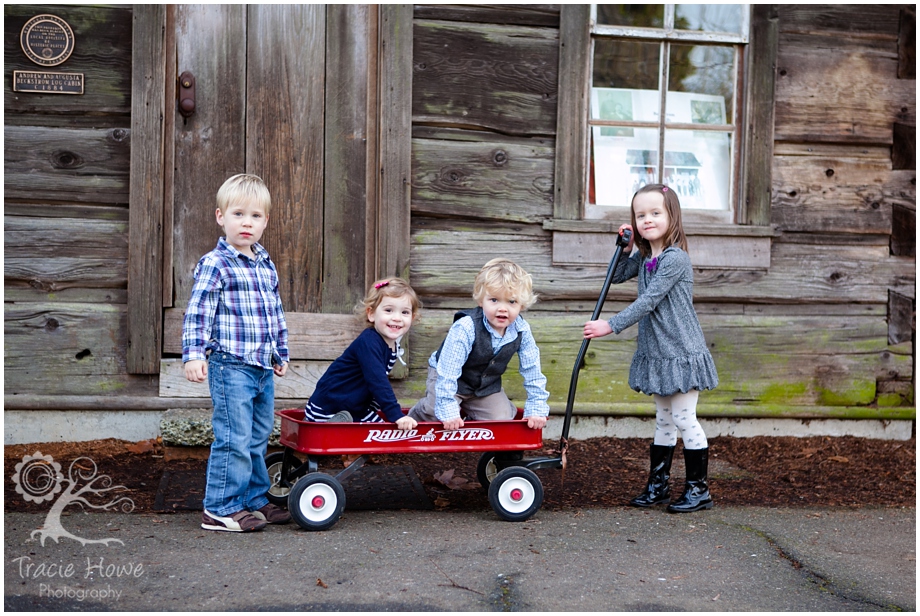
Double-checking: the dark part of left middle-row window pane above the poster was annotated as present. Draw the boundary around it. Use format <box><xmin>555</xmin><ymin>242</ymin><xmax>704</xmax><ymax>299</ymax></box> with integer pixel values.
<box><xmin>592</xmin><ymin>40</ymin><xmax>661</xmax><ymax>90</ymax></box>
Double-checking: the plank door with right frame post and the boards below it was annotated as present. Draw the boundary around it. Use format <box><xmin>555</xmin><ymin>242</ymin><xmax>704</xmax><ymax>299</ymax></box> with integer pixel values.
<box><xmin>160</xmin><ymin>5</ymin><xmax>412</xmax><ymax>397</ymax></box>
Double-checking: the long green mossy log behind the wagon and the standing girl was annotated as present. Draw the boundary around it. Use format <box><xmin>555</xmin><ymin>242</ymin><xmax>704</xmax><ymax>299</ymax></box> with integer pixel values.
<box><xmin>399</xmin><ymin>310</ymin><xmax>912</xmax><ymax>416</ymax></box>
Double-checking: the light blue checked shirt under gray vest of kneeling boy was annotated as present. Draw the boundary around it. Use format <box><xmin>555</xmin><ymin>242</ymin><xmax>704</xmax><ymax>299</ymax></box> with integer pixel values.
<box><xmin>428</xmin><ymin>315</ymin><xmax>549</xmax><ymax>421</ymax></box>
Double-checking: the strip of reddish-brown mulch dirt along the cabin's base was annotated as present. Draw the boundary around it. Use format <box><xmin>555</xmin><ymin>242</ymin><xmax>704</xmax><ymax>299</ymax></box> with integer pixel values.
<box><xmin>4</xmin><ymin>437</ymin><xmax>916</xmax><ymax>513</ymax></box>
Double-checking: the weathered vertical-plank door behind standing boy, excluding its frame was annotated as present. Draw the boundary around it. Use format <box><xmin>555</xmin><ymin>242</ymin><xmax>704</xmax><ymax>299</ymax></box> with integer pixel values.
<box><xmin>172</xmin><ymin>5</ymin><xmax>373</xmax><ymax>313</ymax></box>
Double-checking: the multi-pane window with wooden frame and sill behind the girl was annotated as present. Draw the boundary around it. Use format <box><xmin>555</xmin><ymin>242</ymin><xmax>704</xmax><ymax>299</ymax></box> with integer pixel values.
<box><xmin>544</xmin><ymin>4</ymin><xmax>778</xmax><ymax>268</ymax></box>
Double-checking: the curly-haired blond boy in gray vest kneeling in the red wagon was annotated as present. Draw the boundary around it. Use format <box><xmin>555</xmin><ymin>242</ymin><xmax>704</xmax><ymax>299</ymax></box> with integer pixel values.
<box><xmin>409</xmin><ymin>259</ymin><xmax>549</xmax><ymax>430</ymax></box>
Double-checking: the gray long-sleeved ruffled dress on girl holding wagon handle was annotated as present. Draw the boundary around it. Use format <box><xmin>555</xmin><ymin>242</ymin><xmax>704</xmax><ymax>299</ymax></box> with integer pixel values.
<box><xmin>608</xmin><ymin>246</ymin><xmax>719</xmax><ymax>396</ymax></box>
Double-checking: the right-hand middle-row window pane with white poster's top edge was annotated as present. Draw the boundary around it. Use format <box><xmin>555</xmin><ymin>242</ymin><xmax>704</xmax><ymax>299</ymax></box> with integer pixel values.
<box><xmin>668</xmin><ymin>44</ymin><xmax>735</xmax><ymax>124</ymax></box>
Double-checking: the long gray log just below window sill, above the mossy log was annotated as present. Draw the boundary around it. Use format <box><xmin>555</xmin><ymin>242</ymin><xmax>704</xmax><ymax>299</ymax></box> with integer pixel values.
<box><xmin>412</xmin><ymin>221</ymin><xmax>916</xmax><ymax>304</ymax></box>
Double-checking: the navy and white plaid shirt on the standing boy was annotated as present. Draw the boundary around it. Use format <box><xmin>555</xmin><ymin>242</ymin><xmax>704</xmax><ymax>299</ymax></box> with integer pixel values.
<box><xmin>182</xmin><ymin>237</ymin><xmax>289</xmax><ymax>369</ymax></box>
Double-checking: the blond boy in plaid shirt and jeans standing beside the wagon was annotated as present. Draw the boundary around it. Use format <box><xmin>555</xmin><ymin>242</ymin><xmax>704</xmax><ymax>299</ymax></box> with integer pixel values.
<box><xmin>182</xmin><ymin>174</ymin><xmax>291</xmax><ymax>533</ymax></box>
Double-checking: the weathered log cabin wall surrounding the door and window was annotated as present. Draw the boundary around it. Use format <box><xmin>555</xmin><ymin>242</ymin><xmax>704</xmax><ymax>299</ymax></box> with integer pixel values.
<box><xmin>4</xmin><ymin>5</ymin><xmax>916</xmax><ymax>438</ymax></box>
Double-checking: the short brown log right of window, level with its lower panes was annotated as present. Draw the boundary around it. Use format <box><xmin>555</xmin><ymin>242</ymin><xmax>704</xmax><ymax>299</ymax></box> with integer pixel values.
<box><xmin>772</xmin><ymin>156</ymin><xmax>909</xmax><ymax>234</ymax></box>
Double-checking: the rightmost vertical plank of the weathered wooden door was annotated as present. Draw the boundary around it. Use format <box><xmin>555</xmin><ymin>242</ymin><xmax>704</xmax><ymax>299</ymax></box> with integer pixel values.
<box><xmin>322</xmin><ymin>4</ymin><xmax>377</xmax><ymax>312</ymax></box>
